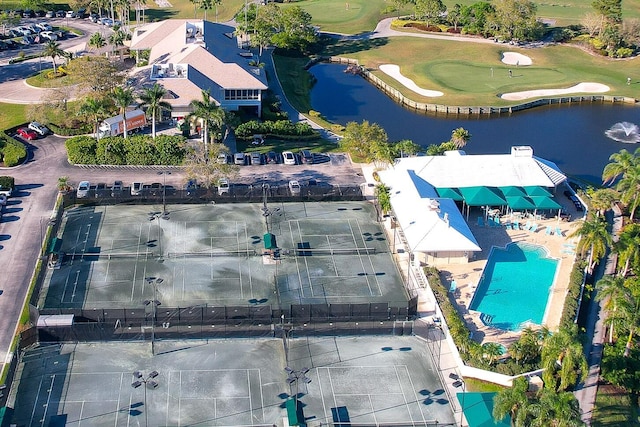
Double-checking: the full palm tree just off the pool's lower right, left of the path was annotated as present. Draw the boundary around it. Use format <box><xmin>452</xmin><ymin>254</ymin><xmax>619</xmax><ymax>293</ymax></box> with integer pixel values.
<box><xmin>541</xmin><ymin>325</ymin><xmax>588</xmax><ymax>391</ymax></box>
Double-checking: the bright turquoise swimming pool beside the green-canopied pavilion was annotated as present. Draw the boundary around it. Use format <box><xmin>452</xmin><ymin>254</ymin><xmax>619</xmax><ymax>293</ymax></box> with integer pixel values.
<box><xmin>469</xmin><ymin>243</ymin><xmax>559</xmax><ymax>331</ymax></box>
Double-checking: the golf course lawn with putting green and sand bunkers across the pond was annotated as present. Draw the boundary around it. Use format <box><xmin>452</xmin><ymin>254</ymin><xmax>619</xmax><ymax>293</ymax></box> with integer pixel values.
<box><xmin>327</xmin><ymin>37</ymin><xmax>640</xmax><ymax>106</ymax></box>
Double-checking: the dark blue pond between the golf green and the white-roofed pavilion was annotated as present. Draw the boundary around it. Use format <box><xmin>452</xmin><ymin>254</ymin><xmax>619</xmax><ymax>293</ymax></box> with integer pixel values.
<box><xmin>310</xmin><ymin>63</ymin><xmax>640</xmax><ymax>183</ymax></box>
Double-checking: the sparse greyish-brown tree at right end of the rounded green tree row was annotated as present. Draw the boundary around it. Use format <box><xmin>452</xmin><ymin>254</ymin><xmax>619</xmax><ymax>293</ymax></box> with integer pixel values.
<box><xmin>184</xmin><ymin>144</ymin><xmax>240</xmax><ymax>188</ymax></box>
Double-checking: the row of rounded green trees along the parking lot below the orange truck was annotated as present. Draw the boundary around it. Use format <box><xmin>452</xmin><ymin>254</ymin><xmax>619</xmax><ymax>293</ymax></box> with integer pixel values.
<box><xmin>65</xmin><ymin>135</ymin><xmax>186</xmax><ymax>166</ymax></box>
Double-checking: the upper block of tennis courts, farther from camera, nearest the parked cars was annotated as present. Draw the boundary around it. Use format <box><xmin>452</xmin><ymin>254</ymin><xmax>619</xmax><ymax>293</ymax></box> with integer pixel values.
<box><xmin>39</xmin><ymin>202</ymin><xmax>407</xmax><ymax>308</ymax></box>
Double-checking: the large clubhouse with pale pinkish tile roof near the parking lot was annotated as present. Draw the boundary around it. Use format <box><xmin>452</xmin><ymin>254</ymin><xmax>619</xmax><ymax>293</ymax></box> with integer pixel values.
<box><xmin>131</xmin><ymin>19</ymin><xmax>268</xmax><ymax>117</ymax></box>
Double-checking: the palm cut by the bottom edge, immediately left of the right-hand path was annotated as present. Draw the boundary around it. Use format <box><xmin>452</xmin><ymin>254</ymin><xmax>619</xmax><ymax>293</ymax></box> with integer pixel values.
<box><xmin>528</xmin><ymin>389</ymin><xmax>584</xmax><ymax>427</ymax></box>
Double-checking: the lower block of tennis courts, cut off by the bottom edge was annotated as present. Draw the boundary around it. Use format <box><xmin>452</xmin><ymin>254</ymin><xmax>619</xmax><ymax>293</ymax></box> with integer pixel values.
<box><xmin>6</xmin><ymin>336</ymin><xmax>454</xmax><ymax>426</ymax></box>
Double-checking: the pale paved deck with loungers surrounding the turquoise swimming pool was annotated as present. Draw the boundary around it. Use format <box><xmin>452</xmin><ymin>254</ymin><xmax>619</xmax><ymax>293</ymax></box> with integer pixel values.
<box><xmin>439</xmin><ymin>206</ymin><xmax>582</xmax><ymax>346</ymax></box>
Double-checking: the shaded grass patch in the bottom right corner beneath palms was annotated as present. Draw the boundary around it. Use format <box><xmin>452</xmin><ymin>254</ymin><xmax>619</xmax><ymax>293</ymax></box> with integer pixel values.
<box><xmin>591</xmin><ymin>385</ymin><xmax>640</xmax><ymax>427</ymax></box>
